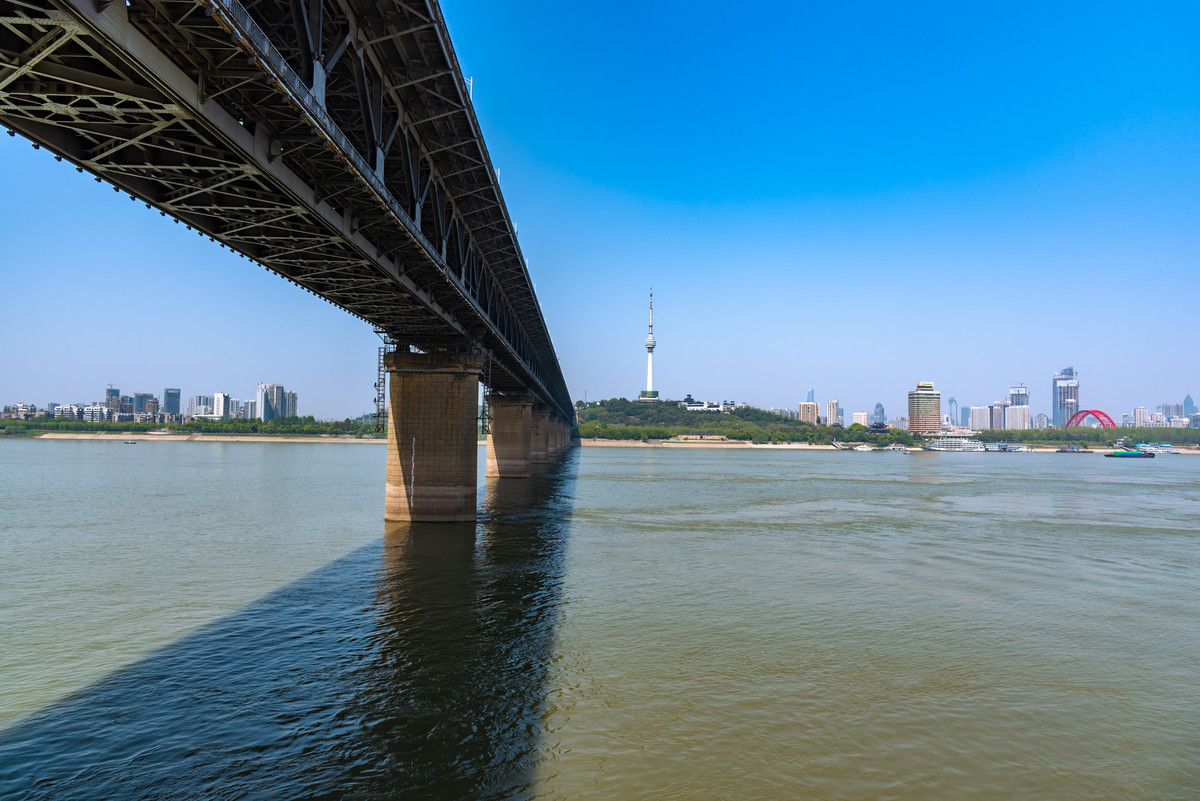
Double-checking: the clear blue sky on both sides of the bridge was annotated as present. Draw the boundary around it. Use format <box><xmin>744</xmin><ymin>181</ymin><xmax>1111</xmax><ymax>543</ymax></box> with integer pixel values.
<box><xmin>0</xmin><ymin>0</ymin><xmax>1200</xmax><ymax>417</ymax></box>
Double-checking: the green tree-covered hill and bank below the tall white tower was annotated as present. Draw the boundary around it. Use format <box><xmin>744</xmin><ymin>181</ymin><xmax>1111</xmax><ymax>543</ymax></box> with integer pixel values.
<box><xmin>576</xmin><ymin>398</ymin><xmax>914</xmax><ymax>446</ymax></box>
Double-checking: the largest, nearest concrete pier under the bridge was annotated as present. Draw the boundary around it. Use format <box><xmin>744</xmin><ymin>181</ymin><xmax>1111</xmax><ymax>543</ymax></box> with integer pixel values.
<box><xmin>384</xmin><ymin>351</ymin><xmax>484</xmax><ymax>523</ymax></box>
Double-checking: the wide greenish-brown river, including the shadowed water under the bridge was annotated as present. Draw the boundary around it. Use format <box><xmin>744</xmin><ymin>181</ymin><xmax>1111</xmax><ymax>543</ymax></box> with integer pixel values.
<box><xmin>0</xmin><ymin>440</ymin><xmax>1200</xmax><ymax>801</ymax></box>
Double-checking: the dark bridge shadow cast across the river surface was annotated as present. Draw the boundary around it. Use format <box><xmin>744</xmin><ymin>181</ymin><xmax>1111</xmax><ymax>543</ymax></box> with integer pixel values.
<box><xmin>0</xmin><ymin>452</ymin><xmax>577</xmax><ymax>801</ymax></box>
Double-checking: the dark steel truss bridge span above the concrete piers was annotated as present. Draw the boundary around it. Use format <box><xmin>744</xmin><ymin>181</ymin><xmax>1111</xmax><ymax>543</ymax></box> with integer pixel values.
<box><xmin>0</xmin><ymin>0</ymin><xmax>572</xmax><ymax>421</ymax></box>
